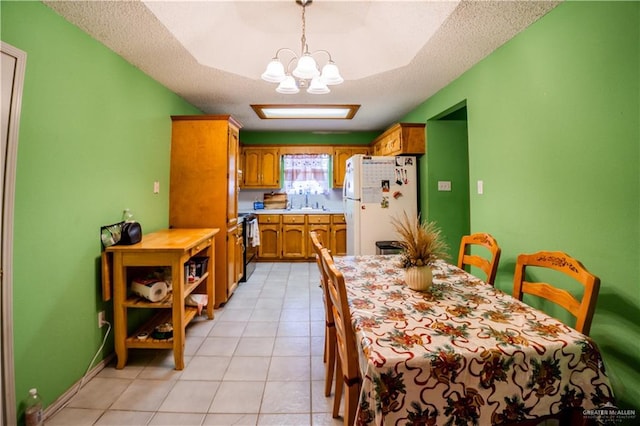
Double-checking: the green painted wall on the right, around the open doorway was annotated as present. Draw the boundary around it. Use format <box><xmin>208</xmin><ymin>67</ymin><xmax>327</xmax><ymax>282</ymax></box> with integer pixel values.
<box><xmin>403</xmin><ymin>2</ymin><xmax>640</xmax><ymax>412</ymax></box>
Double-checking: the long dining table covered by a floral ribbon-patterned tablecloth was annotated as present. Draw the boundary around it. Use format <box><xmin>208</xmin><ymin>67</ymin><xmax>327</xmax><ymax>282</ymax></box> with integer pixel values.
<box><xmin>334</xmin><ymin>255</ymin><xmax>614</xmax><ymax>426</ymax></box>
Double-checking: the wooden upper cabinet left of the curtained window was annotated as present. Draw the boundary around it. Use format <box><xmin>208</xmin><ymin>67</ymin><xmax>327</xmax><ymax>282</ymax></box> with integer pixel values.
<box><xmin>241</xmin><ymin>147</ymin><xmax>280</xmax><ymax>188</ymax></box>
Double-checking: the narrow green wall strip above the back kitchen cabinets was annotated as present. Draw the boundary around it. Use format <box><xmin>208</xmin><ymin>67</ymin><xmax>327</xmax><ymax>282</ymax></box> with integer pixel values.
<box><xmin>240</xmin><ymin>129</ymin><xmax>376</xmax><ymax>145</ymax></box>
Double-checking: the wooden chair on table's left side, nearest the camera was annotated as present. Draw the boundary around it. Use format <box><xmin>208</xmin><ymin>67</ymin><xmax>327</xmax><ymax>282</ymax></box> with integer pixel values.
<box><xmin>321</xmin><ymin>249</ymin><xmax>362</xmax><ymax>426</ymax></box>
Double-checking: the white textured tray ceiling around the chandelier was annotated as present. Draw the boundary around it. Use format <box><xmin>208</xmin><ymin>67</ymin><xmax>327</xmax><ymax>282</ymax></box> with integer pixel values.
<box><xmin>44</xmin><ymin>0</ymin><xmax>559</xmax><ymax>132</ymax></box>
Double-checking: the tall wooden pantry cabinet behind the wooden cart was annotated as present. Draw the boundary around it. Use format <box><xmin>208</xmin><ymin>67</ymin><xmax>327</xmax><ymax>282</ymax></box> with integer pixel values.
<box><xmin>169</xmin><ymin>115</ymin><xmax>242</xmax><ymax>307</ymax></box>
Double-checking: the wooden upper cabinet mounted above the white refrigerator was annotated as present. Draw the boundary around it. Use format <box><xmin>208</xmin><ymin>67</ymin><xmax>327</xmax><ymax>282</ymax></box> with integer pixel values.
<box><xmin>371</xmin><ymin>123</ymin><xmax>426</xmax><ymax>155</ymax></box>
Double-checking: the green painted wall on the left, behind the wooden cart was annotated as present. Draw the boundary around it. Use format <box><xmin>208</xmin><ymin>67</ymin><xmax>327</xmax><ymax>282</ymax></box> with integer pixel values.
<box><xmin>0</xmin><ymin>1</ymin><xmax>199</xmax><ymax>420</ymax></box>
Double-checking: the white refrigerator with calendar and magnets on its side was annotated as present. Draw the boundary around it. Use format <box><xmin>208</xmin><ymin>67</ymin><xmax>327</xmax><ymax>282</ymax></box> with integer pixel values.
<box><xmin>342</xmin><ymin>154</ymin><xmax>418</xmax><ymax>255</ymax></box>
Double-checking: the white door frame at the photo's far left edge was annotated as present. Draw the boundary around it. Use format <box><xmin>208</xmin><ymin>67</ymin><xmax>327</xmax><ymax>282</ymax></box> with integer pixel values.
<box><xmin>0</xmin><ymin>42</ymin><xmax>27</xmax><ymax>425</ymax></box>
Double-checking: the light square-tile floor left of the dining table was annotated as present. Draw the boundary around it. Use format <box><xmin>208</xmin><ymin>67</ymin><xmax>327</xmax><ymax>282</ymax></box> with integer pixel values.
<box><xmin>46</xmin><ymin>263</ymin><xmax>342</xmax><ymax>426</ymax></box>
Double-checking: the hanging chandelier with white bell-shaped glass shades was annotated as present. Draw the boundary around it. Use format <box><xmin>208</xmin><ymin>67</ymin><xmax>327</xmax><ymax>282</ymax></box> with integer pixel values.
<box><xmin>262</xmin><ymin>0</ymin><xmax>344</xmax><ymax>95</ymax></box>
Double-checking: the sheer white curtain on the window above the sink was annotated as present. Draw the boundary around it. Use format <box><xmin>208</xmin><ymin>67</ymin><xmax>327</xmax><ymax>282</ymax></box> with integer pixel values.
<box><xmin>282</xmin><ymin>154</ymin><xmax>330</xmax><ymax>194</ymax></box>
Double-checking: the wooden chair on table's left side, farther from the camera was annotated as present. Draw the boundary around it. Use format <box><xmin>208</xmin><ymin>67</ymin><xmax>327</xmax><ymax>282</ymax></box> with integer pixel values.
<box><xmin>309</xmin><ymin>231</ymin><xmax>336</xmax><ymax>396</ymax></box>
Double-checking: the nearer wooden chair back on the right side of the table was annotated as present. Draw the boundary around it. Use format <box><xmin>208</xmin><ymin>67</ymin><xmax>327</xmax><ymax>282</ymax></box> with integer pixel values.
<box><xmin>513</xmin><ymin>251</ymin><xmax>600</xmax><ymax>335</ymax></box>
